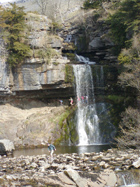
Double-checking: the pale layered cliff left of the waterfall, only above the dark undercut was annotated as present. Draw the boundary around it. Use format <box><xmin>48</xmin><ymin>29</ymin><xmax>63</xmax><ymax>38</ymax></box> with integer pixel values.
<box><xmin>0</xmin><ymin>13</ymin><xmax>72</xmax><ymax>101</ymax></box>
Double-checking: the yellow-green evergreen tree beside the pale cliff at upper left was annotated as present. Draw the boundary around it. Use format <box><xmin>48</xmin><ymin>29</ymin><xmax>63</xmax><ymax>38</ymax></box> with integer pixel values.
<box><xmin>0</xmin><ymin>3</ymin><xmax>30</xmax><ymax>66</ymax></box>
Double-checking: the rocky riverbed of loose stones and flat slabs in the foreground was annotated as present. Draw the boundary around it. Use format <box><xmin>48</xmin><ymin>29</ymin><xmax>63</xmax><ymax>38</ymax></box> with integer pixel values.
<box><xmin>0</xmin><ymin>149</ymin><xmax>140</xmax><ymax>187</ymax></box>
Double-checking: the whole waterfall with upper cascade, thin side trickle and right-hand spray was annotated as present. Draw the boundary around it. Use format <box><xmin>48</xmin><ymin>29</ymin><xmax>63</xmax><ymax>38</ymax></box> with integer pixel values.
<box><xmin>73</xmin><ymin>55</ymin><xmax>116</xmax><ymax>145</ymax></box>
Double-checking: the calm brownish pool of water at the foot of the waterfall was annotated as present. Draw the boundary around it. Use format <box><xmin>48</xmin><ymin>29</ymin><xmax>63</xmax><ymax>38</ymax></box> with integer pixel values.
<box><xmin>13</xmin><ymin>144</ymin><xmax>111</xmax><ymax>157</ymax></box>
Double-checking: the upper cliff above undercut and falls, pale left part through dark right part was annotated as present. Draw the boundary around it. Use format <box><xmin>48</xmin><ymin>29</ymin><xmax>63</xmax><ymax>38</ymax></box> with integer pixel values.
<box><xmin>0</xmin><ymin>1</ymin><xmax>116</xmax><ymax>101</ymax></box>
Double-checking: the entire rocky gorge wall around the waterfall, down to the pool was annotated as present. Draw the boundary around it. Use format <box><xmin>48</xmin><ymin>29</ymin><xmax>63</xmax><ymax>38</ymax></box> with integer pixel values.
<box><xmin>0</xmin><ymin>2</ymin><xmax>136</xmax><ymax>147</ymax></box>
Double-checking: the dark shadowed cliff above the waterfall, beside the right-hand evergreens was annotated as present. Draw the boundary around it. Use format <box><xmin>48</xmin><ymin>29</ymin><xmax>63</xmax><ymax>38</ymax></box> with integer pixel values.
<box><xmin>61</xmin><ymin>2</ymin><xmax>117</xmax><ymax>63</ymax></box>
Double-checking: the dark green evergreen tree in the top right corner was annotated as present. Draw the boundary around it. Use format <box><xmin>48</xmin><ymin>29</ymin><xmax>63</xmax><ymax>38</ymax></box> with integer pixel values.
<box><xmin>108</xmin><ymin>0</ymin><xmax>140</xmax><ymax>54</ymax></box>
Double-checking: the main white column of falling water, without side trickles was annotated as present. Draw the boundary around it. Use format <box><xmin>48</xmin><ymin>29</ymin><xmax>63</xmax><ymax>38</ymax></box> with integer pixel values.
<box><xmin>73</xmin><ymin>65</ymin><xmax>100</xmax><ymax>145</ymax></box>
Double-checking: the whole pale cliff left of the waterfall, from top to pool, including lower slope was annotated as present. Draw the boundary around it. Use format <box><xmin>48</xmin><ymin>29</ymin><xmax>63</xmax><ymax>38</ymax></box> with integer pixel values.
<box><xmin>0</xmin><ymin>13</ymin><xmax>74</xmax><ymax>147</ymax></box>
